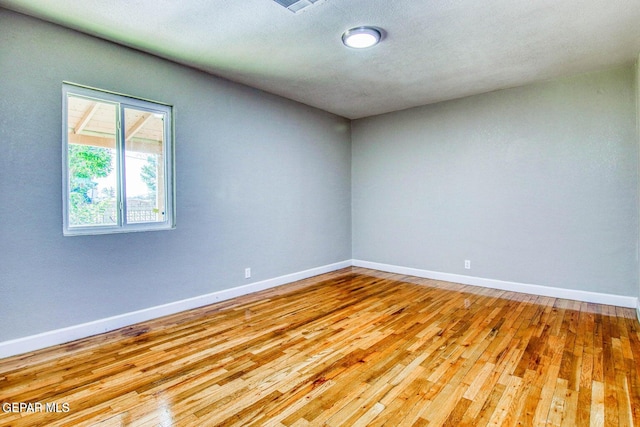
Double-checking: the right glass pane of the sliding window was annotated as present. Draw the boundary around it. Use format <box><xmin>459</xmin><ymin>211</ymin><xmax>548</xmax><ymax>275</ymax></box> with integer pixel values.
<box><xmin>124</xmin><ymin>107</ymin><xmax>165</xmax><ymax>224</ymax></box>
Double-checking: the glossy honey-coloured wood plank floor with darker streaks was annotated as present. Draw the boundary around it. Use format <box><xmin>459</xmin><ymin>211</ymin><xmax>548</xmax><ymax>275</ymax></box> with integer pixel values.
<box><xmin>0</xmin><ymin>267</ymin><xmax>640</xmax><ymax>427</ymax></box>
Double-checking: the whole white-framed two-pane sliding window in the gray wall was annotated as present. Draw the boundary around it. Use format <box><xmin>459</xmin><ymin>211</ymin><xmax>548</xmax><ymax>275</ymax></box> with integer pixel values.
<box><xmin>62</xmin><ymin>84</ymin><xmax>174</xmax><ymax>235</ymax></box>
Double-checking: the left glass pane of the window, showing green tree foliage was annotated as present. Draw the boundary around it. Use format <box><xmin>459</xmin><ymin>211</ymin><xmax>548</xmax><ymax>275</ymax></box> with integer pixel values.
<box><xmin>67</xmin><ymin>95</ymin><xmax>118</xmax><ymax>227</ymax></box>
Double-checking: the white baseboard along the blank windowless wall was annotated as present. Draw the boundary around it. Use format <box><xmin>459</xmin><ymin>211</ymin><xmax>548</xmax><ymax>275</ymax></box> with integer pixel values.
<box><xmin>352</xmin><ymin>259</ymin><xmax>640</xmax><ymax>310</ymax></box>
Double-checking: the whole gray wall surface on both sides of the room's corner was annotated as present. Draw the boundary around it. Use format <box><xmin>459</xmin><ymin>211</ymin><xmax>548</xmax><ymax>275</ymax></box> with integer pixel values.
<box><xmin>0</xmin><ymin>9</ymin><xmax>640</xmax><ymax>341</ymax></box>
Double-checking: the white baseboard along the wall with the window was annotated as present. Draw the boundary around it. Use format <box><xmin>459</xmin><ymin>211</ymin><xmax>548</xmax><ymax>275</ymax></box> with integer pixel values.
<box><xmin>0</xmin><ymin>260</ymin><xmax>351</xmax><ymax>358</ymax></box>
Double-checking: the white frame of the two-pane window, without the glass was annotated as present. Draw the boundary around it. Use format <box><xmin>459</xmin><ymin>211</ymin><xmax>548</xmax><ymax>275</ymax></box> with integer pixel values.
<box><xmin>62</xmin><ymin>82</ymin><xmax>175</xmax><ymax>236</ymax></box>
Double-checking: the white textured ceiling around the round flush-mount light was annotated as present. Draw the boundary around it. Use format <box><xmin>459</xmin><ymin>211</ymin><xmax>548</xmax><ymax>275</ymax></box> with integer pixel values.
<box><xmin>0</xmin><ymin>0</ymin><xmax>640</xmax><ymax>119</ymax></box>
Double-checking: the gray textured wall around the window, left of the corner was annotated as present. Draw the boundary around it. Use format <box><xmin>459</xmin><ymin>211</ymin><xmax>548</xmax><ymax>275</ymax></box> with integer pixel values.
<box><xmin>0</xmin><ymin>9</ymin><xmax>351</xmax><ymax>341</ymax></box>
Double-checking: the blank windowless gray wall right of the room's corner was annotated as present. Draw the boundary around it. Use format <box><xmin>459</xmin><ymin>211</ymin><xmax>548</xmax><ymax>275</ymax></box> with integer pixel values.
<box><xmin>352</xmin><ymin>65</ymin><xmax>638</xmax><ymax>296</ymax></box>
